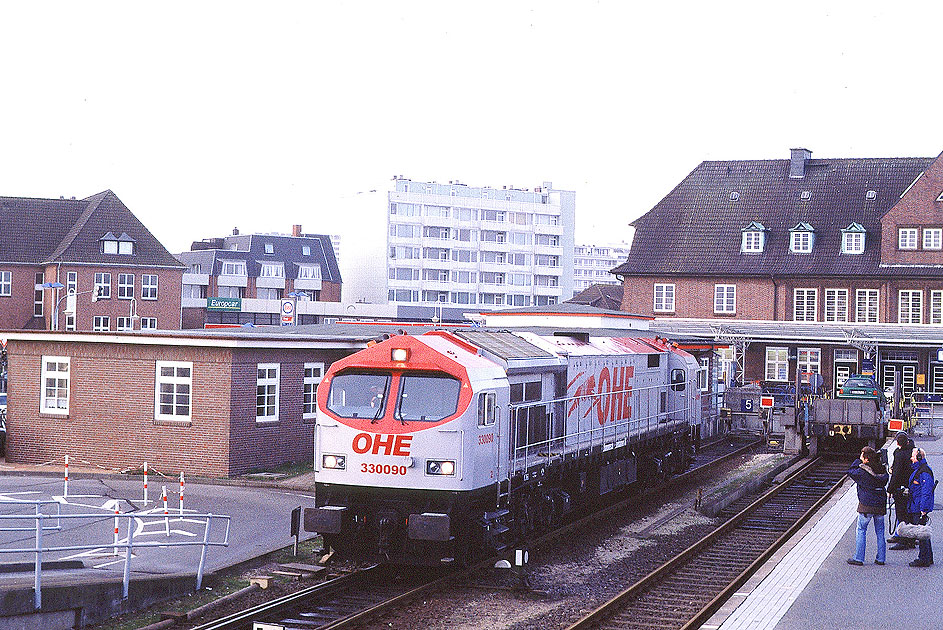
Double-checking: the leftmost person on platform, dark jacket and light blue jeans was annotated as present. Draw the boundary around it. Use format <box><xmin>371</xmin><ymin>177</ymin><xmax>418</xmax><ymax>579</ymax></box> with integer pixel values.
<box><xmin>848</xmin><ymin>446</ymin><xmax>889</xmax><ymax>566</ymax></box>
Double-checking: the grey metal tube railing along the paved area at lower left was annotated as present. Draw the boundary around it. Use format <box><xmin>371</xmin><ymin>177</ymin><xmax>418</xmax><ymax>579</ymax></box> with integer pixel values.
<box><xmin>0</xmin><ymin>501</ymin><xmax>230</xmax><ymax>610</ymax></box>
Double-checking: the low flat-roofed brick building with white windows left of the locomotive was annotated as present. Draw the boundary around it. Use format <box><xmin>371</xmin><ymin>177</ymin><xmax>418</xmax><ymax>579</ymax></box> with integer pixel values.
<box><xmin>6</xmin><ymin>327</ymin><xmax>380</xmax><ymax>477</ymax></box>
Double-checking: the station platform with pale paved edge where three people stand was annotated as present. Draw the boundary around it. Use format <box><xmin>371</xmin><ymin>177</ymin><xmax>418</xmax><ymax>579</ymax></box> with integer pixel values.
<box><xmin>701</xmin><ymin>432</ymin><xmax>943</xmax><ymax>630</ymax></box>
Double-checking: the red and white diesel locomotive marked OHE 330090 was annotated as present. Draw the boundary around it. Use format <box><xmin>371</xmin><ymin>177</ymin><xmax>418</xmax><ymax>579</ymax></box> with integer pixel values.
<box><xmin>304</xmin><ymin>328</ymin><xmax>702</xmax><ymax>565</ymax></box>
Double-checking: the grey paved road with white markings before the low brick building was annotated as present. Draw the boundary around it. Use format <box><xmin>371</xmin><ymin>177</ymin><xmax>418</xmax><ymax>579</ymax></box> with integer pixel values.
<box><xmin>0</xmin><ymin>475</ymin><xmax>314</xmax><ymax>588</ymax></box>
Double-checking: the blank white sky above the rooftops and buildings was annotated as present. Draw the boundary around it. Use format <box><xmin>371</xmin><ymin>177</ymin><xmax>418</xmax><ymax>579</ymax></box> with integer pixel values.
<box><xmin>0</xmin><ymin>0</ymin><xmax>943</xmax><ymax>252</ymax></box>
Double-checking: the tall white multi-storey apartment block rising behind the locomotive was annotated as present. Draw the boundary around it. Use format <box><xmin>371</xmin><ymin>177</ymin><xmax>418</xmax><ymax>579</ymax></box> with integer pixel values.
<box><xmin>386</xmin><ymin>177</ymin><xmax>576</xmax><ymax>318</ymax></box>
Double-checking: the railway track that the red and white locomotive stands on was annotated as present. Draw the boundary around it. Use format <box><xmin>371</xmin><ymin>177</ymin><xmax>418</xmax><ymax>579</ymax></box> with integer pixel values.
<box><xmin>193</xmin><ymin>439</ymin><xmax>762</xmax><ymax>630</ymax></box>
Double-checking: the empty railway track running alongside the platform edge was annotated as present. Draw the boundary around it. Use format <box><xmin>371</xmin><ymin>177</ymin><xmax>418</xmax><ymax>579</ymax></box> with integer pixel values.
<box><xmin>570</xmin><ymin>458</ymin><xmax>848</xmax><ymax>630</ymax></box>
